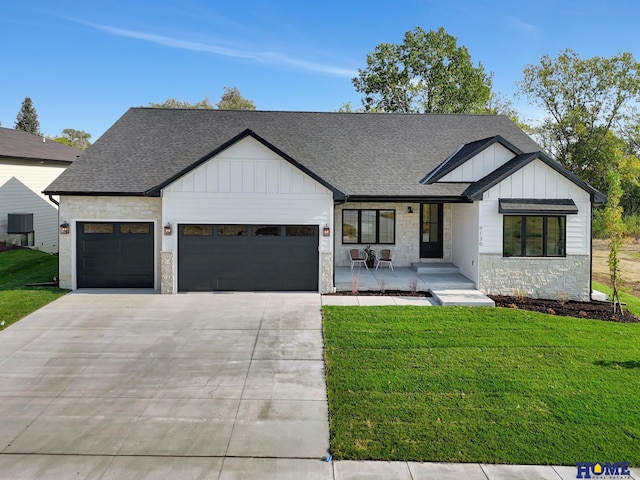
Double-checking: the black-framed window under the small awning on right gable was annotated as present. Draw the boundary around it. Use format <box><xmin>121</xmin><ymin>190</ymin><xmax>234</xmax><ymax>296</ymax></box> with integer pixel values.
<box><xmin>503</xmin><ymin>215</ymin><xmax>567</xmax><ymax>257</ymax></box>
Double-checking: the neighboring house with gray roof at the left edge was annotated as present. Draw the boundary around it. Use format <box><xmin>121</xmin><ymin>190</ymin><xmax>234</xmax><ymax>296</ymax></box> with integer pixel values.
<box><xmin>0</xmin><ymin>128</ymin><xmax>80</xmax><ymax>253</ymax></box>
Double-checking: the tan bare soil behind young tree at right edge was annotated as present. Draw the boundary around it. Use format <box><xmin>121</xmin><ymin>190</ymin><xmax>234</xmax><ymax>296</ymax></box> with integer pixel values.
<box><xmin>593</xmin><ymin>238</ymin><xmax>640</xmax><ymax>297</ymax></box>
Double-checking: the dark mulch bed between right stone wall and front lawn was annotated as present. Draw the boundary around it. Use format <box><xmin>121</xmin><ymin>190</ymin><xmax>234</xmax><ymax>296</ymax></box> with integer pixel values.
<box><xmin>489</xmin><ymin>295</ymin><xmax>640</xmax><ymax>323</ymax></box>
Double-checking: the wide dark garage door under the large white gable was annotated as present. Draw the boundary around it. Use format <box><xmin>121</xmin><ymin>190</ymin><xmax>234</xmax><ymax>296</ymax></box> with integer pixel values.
<box><xmin>178</xmin><ymin>225</ymin><xmax>318</xmax><ymax>292</ymax></box>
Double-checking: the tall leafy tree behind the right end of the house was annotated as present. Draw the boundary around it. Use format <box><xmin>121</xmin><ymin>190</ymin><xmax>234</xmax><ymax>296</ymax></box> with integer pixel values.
<box><xmin>518</xmin><ymin>49</ymin><xmax>640</xmax><ymax>191</ymax></box>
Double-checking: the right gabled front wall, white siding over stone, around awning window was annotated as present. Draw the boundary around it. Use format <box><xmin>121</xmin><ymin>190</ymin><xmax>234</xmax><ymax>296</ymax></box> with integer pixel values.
<box><xmin>478</xmin><ymin>160</ymin><xmax>591</xmax><ymax>301</ymax></box>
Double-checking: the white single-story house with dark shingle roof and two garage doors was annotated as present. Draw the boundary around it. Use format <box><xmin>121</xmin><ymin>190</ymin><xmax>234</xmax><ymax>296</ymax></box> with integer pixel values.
<box><xmin>47</xmin><ymin>108</ymin><xmax>605</xmax><ymax>300</ymax></box>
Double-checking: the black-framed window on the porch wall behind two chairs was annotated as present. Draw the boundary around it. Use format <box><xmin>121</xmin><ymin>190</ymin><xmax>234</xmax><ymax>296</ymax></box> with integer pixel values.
<box><xmin>342</xmin><ymin>209</ymin><xmax>396</xmax><ymax>244</ymax></box>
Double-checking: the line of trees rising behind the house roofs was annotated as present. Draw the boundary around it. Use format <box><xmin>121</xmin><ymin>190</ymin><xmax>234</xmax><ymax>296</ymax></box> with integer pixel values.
<box><xmin>11</xmin><ymin>27</ymin><xmax>640</xmax><ymax>217</ymax></box>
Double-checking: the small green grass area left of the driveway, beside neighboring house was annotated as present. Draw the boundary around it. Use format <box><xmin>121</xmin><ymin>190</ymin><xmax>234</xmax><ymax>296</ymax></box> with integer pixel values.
<box><xmin>0</xmin><ymin>249</ymin><xmax>67</xmax><ymax>329</ymax></box>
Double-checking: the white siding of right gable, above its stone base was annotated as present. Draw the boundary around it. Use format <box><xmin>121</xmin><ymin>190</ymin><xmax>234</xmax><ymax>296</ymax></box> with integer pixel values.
<box><xmin>480</xmin><ymin>160</ymin><xmax>591</xmax><ymax>255</ymax></box>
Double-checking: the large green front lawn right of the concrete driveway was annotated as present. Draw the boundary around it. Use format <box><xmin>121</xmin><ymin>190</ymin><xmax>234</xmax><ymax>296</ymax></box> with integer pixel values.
<box><xmin>323</xmin><ymin>306</ymin><xmax>640</xmax><ymax>465</ymax></box>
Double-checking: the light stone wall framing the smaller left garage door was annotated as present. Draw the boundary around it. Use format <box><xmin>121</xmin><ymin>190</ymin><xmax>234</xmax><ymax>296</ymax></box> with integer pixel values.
<box><xmin>59</xmin><ymin>195</ymin><xmax>162</xmax><ymax>288</ymax></box>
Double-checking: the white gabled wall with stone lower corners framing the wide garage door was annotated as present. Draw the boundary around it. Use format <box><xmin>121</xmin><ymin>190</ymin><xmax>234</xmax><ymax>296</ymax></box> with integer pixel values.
<box><xmin>162</xmin><ymin>137</ymin><xmax>333</xmax><ymax>293</ymax></box>
